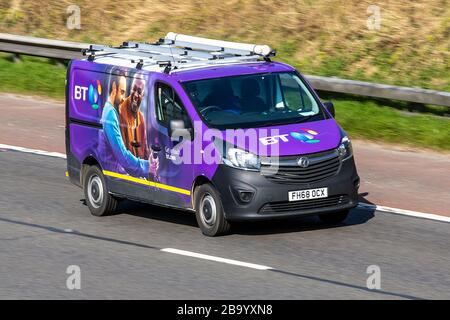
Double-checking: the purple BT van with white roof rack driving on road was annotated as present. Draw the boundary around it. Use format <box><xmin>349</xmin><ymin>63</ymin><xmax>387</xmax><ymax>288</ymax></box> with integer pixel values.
<box><xmin>66</xmin><ymin>32</ymin><xmax>359</xmax><ymax>236</ymax></box>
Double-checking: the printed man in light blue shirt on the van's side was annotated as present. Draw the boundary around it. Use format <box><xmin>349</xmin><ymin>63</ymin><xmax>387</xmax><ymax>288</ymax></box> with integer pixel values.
<box><xmin>99</xmin><ymin>73</ymin><xmax>158</xmax><ymax>179</ymax></box>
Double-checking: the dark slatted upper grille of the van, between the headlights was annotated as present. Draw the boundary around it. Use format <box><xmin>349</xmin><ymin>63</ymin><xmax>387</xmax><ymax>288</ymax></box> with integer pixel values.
<box><xmin>261</xmin><ymin>150</ymin><xmax>341</xmax><ymax>184</ymax></box>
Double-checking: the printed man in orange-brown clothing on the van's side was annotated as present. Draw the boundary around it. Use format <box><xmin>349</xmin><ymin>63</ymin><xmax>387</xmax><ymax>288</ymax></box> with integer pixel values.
<box><xmin>119</xmin><ymin>74</ymin><xmax>149</xmax><ymax>159</ymax></box>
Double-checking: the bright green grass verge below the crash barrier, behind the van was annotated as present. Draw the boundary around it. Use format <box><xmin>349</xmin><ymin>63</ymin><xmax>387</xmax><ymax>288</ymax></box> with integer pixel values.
<box><xmin>0</xmin><ymin>54</ymin><xmax>450</xmax><ymax>151</ymax></box>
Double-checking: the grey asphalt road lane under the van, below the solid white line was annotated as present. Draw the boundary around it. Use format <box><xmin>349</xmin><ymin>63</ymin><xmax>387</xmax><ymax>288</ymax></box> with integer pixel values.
<box><xmin>0</xmin><ymin>151</ymin><xmax>450</xmax><ymax>299</ymax></box>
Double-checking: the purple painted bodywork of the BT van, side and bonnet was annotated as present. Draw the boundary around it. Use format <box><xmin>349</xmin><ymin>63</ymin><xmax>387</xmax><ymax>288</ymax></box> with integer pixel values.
<box><xmin>68</xmin><ymin>60</ymin><xmax>341</xmax><ymax>207</ymax></box>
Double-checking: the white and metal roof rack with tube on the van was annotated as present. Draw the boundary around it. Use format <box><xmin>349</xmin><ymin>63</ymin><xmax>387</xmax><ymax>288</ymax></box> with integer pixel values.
<box><xmin>83</xmin><ymin>32</ymin><xmax>276</xmax><ymax>73</ymax></box>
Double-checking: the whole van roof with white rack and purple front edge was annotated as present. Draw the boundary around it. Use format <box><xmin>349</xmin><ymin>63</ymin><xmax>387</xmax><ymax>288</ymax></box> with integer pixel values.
<box><xmin>83</xmin><ymin>32</ymin><xmax>293</xmax><ymax>81</ymax></box>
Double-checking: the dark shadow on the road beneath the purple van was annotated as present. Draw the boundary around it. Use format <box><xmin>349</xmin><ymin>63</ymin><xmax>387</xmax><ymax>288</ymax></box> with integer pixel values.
<box><xmin>80</xmin><ymin>193</ymin><xmax>375</xmax><ymax>235</ymax></box>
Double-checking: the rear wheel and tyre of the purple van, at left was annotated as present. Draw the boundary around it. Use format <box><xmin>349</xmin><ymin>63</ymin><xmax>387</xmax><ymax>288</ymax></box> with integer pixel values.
<box><xmin>83</xmin><ymin>166</ymin><xmax>118</xmax><ymax>217</ymax></box>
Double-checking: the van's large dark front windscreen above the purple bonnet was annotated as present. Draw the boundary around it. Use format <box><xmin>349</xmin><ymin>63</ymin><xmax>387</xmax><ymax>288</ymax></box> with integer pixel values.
<box><xmin>183</xmin><ymin>72</ymin><xmax>327</xmax><ymax>130</ymax></box>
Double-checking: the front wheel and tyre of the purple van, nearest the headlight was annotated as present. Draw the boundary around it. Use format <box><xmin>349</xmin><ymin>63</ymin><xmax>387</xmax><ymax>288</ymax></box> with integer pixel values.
<box><xmin>194</xmin><ymin>183</ymin><xmax>230</xmax><ymax>237</ymax></box>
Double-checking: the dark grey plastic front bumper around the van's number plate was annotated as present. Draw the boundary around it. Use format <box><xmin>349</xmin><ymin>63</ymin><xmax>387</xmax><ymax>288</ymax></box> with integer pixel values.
<box><xmin>212</xmin><ymin>156</ymin><xmax>359</xmax><ymax>221</ymax></box>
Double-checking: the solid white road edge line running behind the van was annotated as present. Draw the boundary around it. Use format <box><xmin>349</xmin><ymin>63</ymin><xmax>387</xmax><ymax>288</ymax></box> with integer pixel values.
<box><xmin>0</xmin><ymin>143</ymin><xmax>450</xmax><ymax>222</ymax></box>
